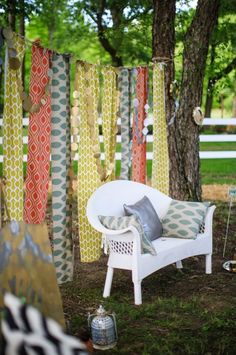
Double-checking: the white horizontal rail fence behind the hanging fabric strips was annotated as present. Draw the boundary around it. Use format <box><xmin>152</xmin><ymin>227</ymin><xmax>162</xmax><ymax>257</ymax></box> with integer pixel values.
<box><xmin>0</xmin><ymin>118</ymin><xmax>236</xmax><ymax>162</ymax></box>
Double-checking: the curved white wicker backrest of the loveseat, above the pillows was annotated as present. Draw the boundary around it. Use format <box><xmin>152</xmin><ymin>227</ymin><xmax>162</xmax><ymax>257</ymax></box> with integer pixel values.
<box><xmin>87</xmin><ymin>180</ymin><xmax>171</xmax><ymax>225</ymax></box>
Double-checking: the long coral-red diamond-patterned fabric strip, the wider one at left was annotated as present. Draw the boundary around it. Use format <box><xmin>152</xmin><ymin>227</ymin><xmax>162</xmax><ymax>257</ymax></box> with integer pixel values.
<box><xmin>24</xmin><ymin>45</ymin><xmax>51</xmax><ymax>224</ymax></box>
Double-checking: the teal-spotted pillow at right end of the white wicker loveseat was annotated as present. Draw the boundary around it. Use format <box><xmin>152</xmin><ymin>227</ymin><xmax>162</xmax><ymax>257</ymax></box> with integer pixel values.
<box><xmin>162</xmin><ymin>200</ymin><xmax>210</xmax><ymax>239</ymax></box>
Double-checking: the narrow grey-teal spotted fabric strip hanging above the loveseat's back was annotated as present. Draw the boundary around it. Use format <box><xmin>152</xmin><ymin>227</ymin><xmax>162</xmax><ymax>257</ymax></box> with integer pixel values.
<box><xmin>118</xmin><ymin>68</ymin><xmax>130</xmax><ymax>180</ymax></box>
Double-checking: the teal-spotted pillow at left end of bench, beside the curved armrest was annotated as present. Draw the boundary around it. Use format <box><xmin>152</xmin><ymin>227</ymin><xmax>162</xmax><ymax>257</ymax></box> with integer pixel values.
<box><xmin>98</xmin><ymin>215</ymin><xmax>156</xmax><ymax>255</ymax></box>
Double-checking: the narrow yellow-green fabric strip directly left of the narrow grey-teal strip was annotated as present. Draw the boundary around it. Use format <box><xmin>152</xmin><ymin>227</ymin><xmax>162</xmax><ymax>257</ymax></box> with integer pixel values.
<box><xmin>102</xmin><ymin>67</ymin><xmax>118</xmax><ymax>181</ymax></box>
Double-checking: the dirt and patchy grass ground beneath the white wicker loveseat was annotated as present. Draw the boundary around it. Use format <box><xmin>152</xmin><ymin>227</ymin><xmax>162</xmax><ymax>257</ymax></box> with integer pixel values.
<box><xmin>58</xmin><ymin>202</ymin><xmax>236</xmax><ymax>355</ymax></box>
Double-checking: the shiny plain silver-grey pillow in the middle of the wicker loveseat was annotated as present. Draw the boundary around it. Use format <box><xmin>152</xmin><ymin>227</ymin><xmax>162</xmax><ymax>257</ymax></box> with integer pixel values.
<box><xmin>124</xmin><ymin>196</ymin><xmax>162</xmax><ymax>241</ymax></box>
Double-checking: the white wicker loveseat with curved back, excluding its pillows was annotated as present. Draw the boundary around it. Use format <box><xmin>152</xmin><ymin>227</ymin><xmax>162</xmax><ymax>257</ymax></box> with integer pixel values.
<box><xmin>87</xmin><ymin>180</ymin><xmax>215</xmax><ymax>305</ymax></box>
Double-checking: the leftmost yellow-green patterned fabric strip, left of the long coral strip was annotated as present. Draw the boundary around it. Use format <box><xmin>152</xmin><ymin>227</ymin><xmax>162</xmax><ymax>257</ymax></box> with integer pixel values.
<box><xmin>3</xmin><ymin>33</ymin><xmax>25</xmax><ymax>221</ymax></box>
